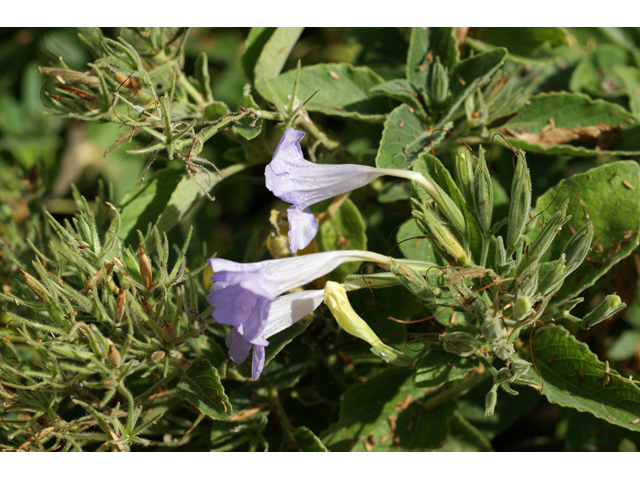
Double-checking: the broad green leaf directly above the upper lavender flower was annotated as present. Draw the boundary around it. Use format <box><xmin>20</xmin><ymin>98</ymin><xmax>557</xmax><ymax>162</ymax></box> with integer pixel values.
<box><xmin>256</xmin><ymin>63</ymin><xmax>391</xmax><ymax>122</ymax></box>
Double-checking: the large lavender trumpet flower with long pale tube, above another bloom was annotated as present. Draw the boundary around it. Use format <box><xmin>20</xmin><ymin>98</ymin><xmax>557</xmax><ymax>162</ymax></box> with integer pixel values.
<box><xmin>207</xmin><ymin>250</ymin><xmax>389</xmax><ymax>344</ymax></box>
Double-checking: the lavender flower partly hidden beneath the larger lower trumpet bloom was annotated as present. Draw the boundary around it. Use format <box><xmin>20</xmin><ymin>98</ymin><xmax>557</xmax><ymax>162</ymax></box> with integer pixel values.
<box><xmin>225</xmin><ymin>290</ymin><xmax>324</xmax><ymax>380</ymax></box>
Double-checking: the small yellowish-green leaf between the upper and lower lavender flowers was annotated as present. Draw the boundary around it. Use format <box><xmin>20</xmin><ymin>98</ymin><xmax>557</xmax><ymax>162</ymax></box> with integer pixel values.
<box><xmin>311</xmin><ymin>198</ymin><xmax>367</xmax><ymax>282</ymax></box>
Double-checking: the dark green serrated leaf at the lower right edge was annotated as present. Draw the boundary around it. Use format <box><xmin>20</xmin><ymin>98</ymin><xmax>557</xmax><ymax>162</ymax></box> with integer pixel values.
<box><xmin>530</xmin><ymin>327</ymin><xmax>640</xmax><ymax>432</ymax></box>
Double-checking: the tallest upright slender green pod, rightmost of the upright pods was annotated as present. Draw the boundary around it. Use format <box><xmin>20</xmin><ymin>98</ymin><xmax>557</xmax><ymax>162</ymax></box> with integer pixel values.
<box><xmin>507</xmin><ymin>150</ymin><xmax>531</xmax><ymax>256</ymax></box>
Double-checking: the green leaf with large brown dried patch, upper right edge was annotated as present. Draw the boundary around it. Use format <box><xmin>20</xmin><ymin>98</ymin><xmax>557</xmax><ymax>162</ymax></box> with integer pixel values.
<box><xmin>502</xmin><ymin>92</ymin><xmax>640</xmax><ymax>156</ymax></box>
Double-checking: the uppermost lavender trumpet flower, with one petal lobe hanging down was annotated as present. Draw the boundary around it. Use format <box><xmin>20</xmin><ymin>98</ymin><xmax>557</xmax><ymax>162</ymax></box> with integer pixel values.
<box><xmin>264</xmin><ymin>127</ymin><xmax>387</xmax><ymax>253</ymax></box>
